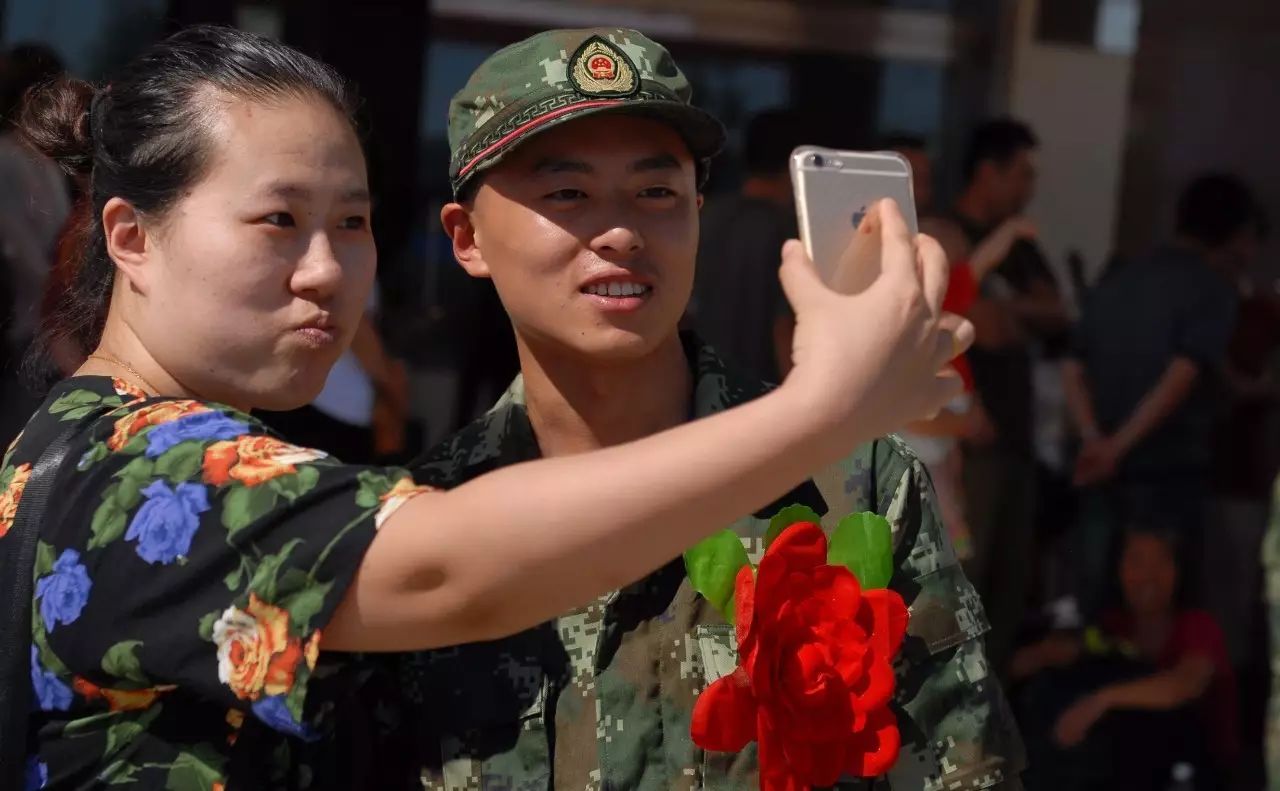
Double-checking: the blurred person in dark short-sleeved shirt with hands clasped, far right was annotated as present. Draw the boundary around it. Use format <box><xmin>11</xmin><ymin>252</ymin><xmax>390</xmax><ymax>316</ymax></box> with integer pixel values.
<box><xmin>1064</xmin><ymin>174</ymin><xmax>1265</xmax><ymax>609</ymax></box>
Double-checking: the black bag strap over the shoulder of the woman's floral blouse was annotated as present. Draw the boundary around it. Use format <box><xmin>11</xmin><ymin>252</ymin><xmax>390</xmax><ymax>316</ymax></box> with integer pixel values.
<box><xmin>0</xmin><ymin>417</ymin><xmax>87</xmax><ymax>791</ymax></box>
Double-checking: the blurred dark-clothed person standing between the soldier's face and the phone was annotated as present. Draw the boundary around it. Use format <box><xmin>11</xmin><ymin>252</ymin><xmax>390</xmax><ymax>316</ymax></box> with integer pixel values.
<box><xmin>689</xmin><ymin>110</ymin><xmax>805</xmax><ymax>381</ymax></box>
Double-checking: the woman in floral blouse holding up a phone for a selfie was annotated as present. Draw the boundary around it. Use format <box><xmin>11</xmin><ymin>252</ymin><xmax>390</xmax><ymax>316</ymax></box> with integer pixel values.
<box><xmin>0</xmin><ymin>27</ymin><xmax>972</xmax><ymax>788</ymax></box>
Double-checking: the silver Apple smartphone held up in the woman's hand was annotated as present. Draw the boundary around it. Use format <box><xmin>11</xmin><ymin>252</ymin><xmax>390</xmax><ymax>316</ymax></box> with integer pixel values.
<box><xmin>791</xmin><ymin>146</ymin><xmax>918</xmax><ymax>283</ymax></box>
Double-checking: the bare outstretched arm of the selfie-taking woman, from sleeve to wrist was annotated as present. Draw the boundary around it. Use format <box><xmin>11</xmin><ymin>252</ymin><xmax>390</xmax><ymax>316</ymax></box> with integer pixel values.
<box><xmin>325</xmin><ymin>387</ymin><xmax>849</xmax><ymax>650</ymax></box>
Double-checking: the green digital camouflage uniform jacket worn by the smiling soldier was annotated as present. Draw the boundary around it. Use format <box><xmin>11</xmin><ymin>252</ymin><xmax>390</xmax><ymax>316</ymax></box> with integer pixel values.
<box><xmin>401</xmin><ymin>338</ymin><xmax>1024</xmax><ymax>791</ymax></box>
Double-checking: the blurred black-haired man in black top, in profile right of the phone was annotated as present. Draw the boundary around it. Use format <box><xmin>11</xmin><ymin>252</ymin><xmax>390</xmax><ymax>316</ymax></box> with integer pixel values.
<box><xmin>928</xmin><ymin>119</ymin><xmax>1068</xmax><ymax>671</ymax></box>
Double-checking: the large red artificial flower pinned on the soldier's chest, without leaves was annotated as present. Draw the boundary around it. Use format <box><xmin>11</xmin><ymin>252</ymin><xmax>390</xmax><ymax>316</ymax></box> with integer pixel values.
<box><xmin>691</xmin><ymin>522</ymin><xmax>908</xmax><ymax>791</ymax></box>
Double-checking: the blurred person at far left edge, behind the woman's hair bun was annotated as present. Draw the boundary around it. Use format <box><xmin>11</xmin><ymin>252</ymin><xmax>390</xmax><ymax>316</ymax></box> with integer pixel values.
<box><xmin>0</xmin><ymin>44</ymin><xmax>70</xmax><ymax>447</ymax></box>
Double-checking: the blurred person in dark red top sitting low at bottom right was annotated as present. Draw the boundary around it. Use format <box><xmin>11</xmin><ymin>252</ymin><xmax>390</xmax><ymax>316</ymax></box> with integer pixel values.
<box><xmin>1012</xmin><ymin>529</ymin><xmax>1239</xmax><ymax>791</ymax></box>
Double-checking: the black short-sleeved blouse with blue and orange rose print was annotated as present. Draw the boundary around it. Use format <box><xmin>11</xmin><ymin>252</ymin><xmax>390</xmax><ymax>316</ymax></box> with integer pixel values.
<box><xmin>0</xmin><ymin>376</ymin><xmax>426</xmax><ymax>791</ymax></box>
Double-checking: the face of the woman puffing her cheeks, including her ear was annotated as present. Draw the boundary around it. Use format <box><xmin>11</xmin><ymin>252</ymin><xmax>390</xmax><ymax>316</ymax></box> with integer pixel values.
<box><xmin>118</xmin><ymin>95</ymin><xmax>376</xmax><ymax>410</ymax></box>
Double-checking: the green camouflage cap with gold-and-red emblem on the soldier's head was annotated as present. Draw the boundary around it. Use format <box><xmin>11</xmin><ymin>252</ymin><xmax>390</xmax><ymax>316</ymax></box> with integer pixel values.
<box><xmin>449</xmin><ymin>28</ymin><xmax>724</xmax><ymax>195</ymax></box>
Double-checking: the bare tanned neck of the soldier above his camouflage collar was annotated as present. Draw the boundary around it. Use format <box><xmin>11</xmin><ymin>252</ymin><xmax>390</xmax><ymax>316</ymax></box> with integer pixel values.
<box><xmin>516</xmin><ymin>333</ymin><xmax>692</xmax><ymax>457</ymax></box>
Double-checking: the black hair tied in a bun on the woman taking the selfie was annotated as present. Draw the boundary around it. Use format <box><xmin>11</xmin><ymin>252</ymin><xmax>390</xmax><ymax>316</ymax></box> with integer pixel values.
<box><xmin>19</xmin><ymin>26</ymin><xmax>356</xmax><ymax>353</ymax></box>
